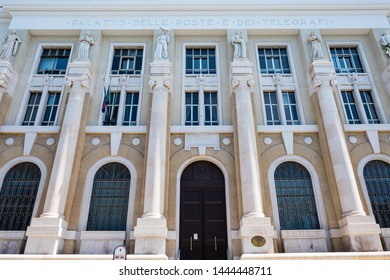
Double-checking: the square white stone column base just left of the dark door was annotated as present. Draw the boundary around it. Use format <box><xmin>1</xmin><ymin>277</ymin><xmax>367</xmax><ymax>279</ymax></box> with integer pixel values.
<box><xmin>134</xmin><ymin>218</ymin><xmax>168</xmax><ymax>255</ymax></box>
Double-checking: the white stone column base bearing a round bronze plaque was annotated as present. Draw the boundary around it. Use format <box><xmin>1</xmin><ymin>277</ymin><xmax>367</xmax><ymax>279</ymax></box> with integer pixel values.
<box><xmin>239</xmin><ymin>217</ymin><xmax>274</xmax><ymax>254</ymax></box>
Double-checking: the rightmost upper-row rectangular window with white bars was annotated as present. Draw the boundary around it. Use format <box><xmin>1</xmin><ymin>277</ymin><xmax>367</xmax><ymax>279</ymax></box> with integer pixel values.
<box><xmin>330</xmin><ymin>47</ymin><xmax>364</xmax><ymax>73</ymax></box>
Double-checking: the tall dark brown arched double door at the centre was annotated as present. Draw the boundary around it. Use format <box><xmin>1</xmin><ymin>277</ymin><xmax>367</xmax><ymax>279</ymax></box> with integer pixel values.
<box><xmin>179</xmin><ymin>161</ymin><xmax>227</xmax><ymax>260</ymax></box>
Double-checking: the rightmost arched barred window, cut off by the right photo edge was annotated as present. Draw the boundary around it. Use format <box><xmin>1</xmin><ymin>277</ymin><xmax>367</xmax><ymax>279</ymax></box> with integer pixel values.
<box><xmin>363</xmin><ymin>160</ymin><xmax>390</xmax><ymax>228</ymax></box>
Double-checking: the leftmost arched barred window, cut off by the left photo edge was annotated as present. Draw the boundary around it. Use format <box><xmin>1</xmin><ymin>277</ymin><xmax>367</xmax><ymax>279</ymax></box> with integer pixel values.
<box><xmin>0</xmin><ymin>162</ymin><xmax>41</xmax><ymax>230</ymax></box>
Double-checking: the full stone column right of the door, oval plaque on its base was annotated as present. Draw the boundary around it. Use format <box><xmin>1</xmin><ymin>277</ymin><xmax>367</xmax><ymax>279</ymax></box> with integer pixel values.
<box><xmin>230</xmin><ymin>59</ymin><xmax>274</xmax><ymax>254</ymax></box>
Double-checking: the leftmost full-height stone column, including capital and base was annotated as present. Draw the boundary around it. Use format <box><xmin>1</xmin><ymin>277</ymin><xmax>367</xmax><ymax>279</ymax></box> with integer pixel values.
<box><xmin>25</xmin><ymin>61</ymin><xmax>92</xmax><ymax>254</ymax></box>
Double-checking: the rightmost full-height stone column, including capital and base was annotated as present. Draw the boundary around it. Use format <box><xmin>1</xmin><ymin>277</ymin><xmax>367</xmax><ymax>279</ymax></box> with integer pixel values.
<box><xmin>310</xmin><ymin>60</ymin><xmax>382</xmax><ymax>251</ymax></box>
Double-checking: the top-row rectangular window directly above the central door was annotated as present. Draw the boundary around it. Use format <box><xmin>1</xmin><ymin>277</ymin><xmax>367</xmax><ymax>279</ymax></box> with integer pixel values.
<box><xmin>186</xmin><ymin>48</ymin><xmax>217</xmax><ymax>75</ymax></box>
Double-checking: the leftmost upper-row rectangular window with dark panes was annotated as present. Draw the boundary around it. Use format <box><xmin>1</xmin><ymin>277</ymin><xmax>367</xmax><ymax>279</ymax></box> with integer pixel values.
<box><xmin>37</xmin><ymin>49</ymin><xmax>70</xmax><ymax>75</ymax></box>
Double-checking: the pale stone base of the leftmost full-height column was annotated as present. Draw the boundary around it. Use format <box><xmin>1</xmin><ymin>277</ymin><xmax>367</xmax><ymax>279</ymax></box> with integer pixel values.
<box><xmin>24</xmin><ymin>218</ymin><xmax>68</xmax><ymax>255</ymax></box>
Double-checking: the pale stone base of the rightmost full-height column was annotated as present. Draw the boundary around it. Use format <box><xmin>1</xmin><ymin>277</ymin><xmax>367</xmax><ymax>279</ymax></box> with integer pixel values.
<box><xmin>339</xmin><ymin>215</ymin><xmax>383</xmax><ymax>252</ymax></box>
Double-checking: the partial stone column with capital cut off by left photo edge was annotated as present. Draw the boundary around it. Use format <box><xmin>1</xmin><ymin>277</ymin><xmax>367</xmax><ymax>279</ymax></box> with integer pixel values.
<box><xmin>0</xmin><ymin>60</ymin><xmax>18</xmax><ymax>126</ymax></box>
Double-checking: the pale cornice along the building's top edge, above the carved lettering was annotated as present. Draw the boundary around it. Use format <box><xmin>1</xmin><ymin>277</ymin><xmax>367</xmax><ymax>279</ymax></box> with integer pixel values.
<box><xmin>0</xmin><ymin>0</ymin><xmax>390</xmax><ymax>15</ymax></box>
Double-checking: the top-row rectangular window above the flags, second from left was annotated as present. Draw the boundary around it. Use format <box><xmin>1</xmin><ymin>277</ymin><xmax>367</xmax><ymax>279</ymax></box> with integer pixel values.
<box><xmin>111</xmin><ymin>48</ymin><xmax>143</xmax><ymax>75</ymax></box>
